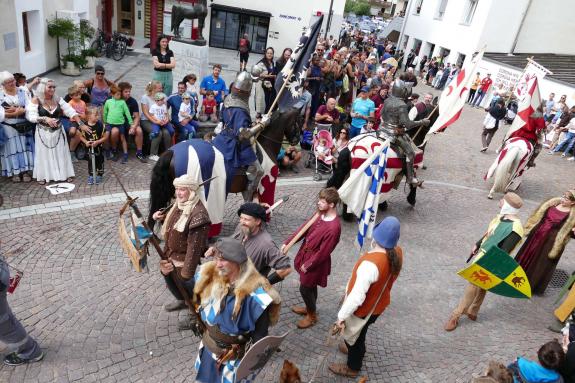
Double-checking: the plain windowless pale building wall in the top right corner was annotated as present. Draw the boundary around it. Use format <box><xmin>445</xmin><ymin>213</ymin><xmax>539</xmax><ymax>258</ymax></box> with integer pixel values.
<box><xmin>516</xmin><ymin>0</ymin><xmax>575</xmax><ymax>55</ymax></box>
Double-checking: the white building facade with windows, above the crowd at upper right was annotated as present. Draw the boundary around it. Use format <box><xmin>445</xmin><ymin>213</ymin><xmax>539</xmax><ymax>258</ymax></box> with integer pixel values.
<box><xmin>404</xmin><ymin>0</ymin><xmax>496</xmax><ymax>62</ymax></box>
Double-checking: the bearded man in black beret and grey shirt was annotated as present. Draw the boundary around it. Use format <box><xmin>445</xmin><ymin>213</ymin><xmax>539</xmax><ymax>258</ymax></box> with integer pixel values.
<box><xmin>230</xmin><ymin>202</ymin><xmax>292</xmax><ymax>285</ymax></box>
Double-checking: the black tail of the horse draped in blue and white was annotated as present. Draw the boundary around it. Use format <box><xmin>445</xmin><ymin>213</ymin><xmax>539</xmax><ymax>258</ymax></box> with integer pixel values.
<box><xmin>148</xmin><ymin>150</ymin><xmax>176</xmax><ymax>228</ymax></box>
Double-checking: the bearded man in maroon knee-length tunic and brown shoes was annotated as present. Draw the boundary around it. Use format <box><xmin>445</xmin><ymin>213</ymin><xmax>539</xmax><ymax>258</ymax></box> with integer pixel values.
<box><xmin>281</xmin><ymin>187</ymin><xmax>341</xmax><ymax>329</ymax></box>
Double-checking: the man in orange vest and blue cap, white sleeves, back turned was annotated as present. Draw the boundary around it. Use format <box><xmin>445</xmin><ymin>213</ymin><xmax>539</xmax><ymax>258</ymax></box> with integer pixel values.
<box><xmin>329</xmin><ymin>216</ymin><xmax>403</xmax><ymax>378</ymax></box>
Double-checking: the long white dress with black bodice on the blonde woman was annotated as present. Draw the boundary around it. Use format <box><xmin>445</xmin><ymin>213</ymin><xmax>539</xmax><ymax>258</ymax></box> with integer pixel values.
<box><xmin>26</xmin><ymin>98</ymin><xmax>77</xmax><ymax>182</ymax></box>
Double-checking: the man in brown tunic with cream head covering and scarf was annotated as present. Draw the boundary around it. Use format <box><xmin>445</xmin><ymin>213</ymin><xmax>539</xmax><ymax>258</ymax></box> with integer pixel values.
<box><xmin>153</xmin><ymin>174</ymin><xmax>210</xmax><ymax>329</ymax></box>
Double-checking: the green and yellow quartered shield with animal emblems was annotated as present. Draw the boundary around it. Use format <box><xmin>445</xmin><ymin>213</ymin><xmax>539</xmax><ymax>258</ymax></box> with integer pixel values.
<box><xmin>457</xmin><ymin>246</ymin><xmax>531</xmax><ymax>298</ymax></box>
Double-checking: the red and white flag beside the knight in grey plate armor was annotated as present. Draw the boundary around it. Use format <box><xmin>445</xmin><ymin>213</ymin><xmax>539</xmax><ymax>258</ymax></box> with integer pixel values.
<box><xmin>427</xmin><ymin>48</ymin><xmax>485</xmax><ymax>135</ymax></box>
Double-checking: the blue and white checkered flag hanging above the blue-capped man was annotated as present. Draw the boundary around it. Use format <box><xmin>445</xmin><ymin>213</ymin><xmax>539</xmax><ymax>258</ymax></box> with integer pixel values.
<box><xmin>357</xmin><ymin>144</ymin><xmax>389</xmax><ymax>249</ymax></box>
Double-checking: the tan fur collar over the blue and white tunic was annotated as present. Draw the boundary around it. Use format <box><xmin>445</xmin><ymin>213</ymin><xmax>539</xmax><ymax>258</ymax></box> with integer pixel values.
<box><xmin>194</xmin><ymin>259</ymin><xmax>281</xmax><ymax>326</ymax></box>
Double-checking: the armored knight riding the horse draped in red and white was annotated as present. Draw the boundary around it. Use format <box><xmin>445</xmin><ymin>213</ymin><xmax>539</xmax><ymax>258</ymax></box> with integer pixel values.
<box><xmin>379</xmin><ymin>78</ymin><xmax>429</xmax><ymax>186</ymax></box>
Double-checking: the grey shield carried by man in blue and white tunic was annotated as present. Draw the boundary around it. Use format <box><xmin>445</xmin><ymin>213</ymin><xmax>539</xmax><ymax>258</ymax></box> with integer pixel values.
<box><xmin>236</xmin><ymin>332</ymin><xmax>288</xmax><ymax>383</ymax></box>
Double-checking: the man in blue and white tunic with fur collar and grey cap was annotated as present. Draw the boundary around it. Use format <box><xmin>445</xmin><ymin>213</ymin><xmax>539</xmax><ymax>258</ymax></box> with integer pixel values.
<box><xmin>194</xmin><ymin>238</ymin><xmax>280</xmax><ymax>383</ymax></box>
